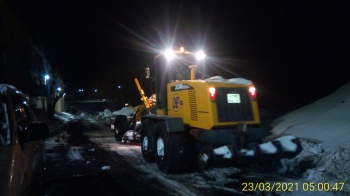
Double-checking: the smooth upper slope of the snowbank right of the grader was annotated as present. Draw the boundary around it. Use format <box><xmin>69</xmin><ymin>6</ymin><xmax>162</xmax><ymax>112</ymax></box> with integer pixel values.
<box><xmin>271</xmin><ymin>83</ymin><xmax>350</xmax><ymax>148</ymax></box>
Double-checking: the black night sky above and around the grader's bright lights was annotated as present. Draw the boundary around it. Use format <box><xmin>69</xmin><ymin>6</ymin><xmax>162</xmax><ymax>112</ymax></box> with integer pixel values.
<box><xmin>10</xmin><ymin>0</ymin><xmax>350</xmax><ymax>113</ymax></box>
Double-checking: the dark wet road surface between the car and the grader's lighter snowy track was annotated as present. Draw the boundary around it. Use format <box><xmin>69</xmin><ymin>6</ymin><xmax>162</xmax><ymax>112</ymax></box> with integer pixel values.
<box><xmin>43</xmin><ymin>117</ymin><xmax>176</xmax><ymax>196</ymax></box>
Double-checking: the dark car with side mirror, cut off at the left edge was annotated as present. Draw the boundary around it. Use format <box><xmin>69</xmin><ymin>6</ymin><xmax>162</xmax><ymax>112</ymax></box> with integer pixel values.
<box><xmin>0</xmin><ymin>84</ymin><xmax>49</xmax><ymax>196</ymax></box>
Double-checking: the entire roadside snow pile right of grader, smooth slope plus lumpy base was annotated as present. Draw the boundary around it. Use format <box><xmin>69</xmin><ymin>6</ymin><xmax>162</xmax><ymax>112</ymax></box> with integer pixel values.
<box><xmin>271</xmin><ymin>83</ymin><xmax>350</xmax><ymax>186</ymax></box>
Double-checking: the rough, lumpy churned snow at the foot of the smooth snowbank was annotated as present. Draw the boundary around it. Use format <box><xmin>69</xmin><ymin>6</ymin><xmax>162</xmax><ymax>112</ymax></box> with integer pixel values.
<box><xmin>280</xmin><ymin>140</ymin><xmax>350</xmax><ymax>186</ymax></box>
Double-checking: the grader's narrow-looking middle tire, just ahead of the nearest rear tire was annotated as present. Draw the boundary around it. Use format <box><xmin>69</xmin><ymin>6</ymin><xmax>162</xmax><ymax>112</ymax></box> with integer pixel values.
<box><xmin>140</xmin><ymin>119</ymin><xmax>156</xmax><ymax>163</ymax></box>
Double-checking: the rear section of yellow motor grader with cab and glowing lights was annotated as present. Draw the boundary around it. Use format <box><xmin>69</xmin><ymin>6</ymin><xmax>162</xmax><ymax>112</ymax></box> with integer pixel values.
<box><xmin>139</xmin><ymin>47</ymin><xmax>301</xmax><ymax>173</ymax></box>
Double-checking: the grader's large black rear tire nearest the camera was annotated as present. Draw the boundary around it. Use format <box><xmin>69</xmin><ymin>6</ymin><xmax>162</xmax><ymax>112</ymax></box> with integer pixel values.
<box><xmin>155</xmin><ymin>122</ymin><xmax>185</xmax><ymax>173</ymax></box>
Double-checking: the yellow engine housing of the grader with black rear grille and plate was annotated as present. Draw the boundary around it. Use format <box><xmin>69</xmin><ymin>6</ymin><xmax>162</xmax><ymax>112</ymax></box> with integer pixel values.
<box><xmin>167</xmin><ymin>80</ymin><xmax>260</xmax><ymax>130</ymax></box>
